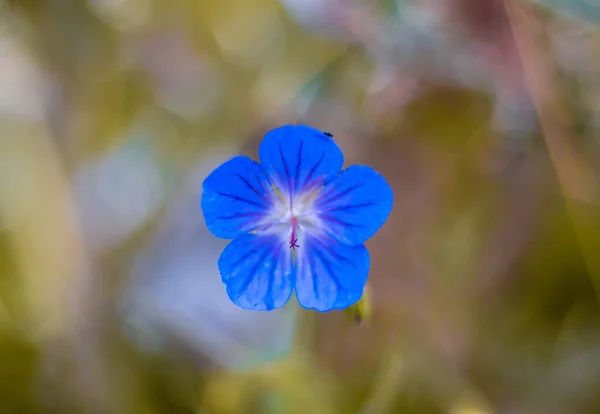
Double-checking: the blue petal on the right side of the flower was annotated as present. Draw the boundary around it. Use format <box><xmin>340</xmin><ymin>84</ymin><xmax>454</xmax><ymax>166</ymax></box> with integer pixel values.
<box><xmin>314</xmin><ymin>165</ymin><xmax>394</xmax><ymax>246</ymax></box>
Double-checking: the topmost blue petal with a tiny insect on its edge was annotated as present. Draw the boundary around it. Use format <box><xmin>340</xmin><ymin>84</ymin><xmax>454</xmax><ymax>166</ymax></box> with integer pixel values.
<box><xmin>258</xmin><ymin>125</ymin><xmax>344</xmax><ymax>200</ymax></box>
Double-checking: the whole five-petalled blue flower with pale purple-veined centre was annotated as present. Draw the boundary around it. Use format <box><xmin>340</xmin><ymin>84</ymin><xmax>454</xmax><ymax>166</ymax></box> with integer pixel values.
<box><xmin>202</xmin><ymin>125</ymin><xmax>394</xmax><ymax>311</ymax></box>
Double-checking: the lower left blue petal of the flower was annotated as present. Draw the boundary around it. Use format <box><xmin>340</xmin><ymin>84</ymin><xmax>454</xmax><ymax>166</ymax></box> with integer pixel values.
<box><xmin>219</xmin><ymin>233</ymin><xmax>293</xmax><ymax>310</ymax></box>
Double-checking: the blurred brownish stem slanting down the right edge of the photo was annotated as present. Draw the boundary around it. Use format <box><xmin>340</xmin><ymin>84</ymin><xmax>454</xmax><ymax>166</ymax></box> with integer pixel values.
<box><xmin>504</xmin><ymin>0</ymin><xmax>600</xmax><ymax>296</ymax></box>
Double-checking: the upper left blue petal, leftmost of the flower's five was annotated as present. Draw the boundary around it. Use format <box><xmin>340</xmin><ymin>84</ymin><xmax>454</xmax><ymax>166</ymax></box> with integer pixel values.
<box><xmin>201</xmin><ymin>157</ymin><xmax>274</xmax><ymax>239</ymax></box>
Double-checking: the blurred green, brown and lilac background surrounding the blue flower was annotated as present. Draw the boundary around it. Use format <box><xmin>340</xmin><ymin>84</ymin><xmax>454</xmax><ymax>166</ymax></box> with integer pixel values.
<box><xmin>0</xmin><ymin>0</ymin><xmax>600</xmax><ymax>414</ymax></box>
